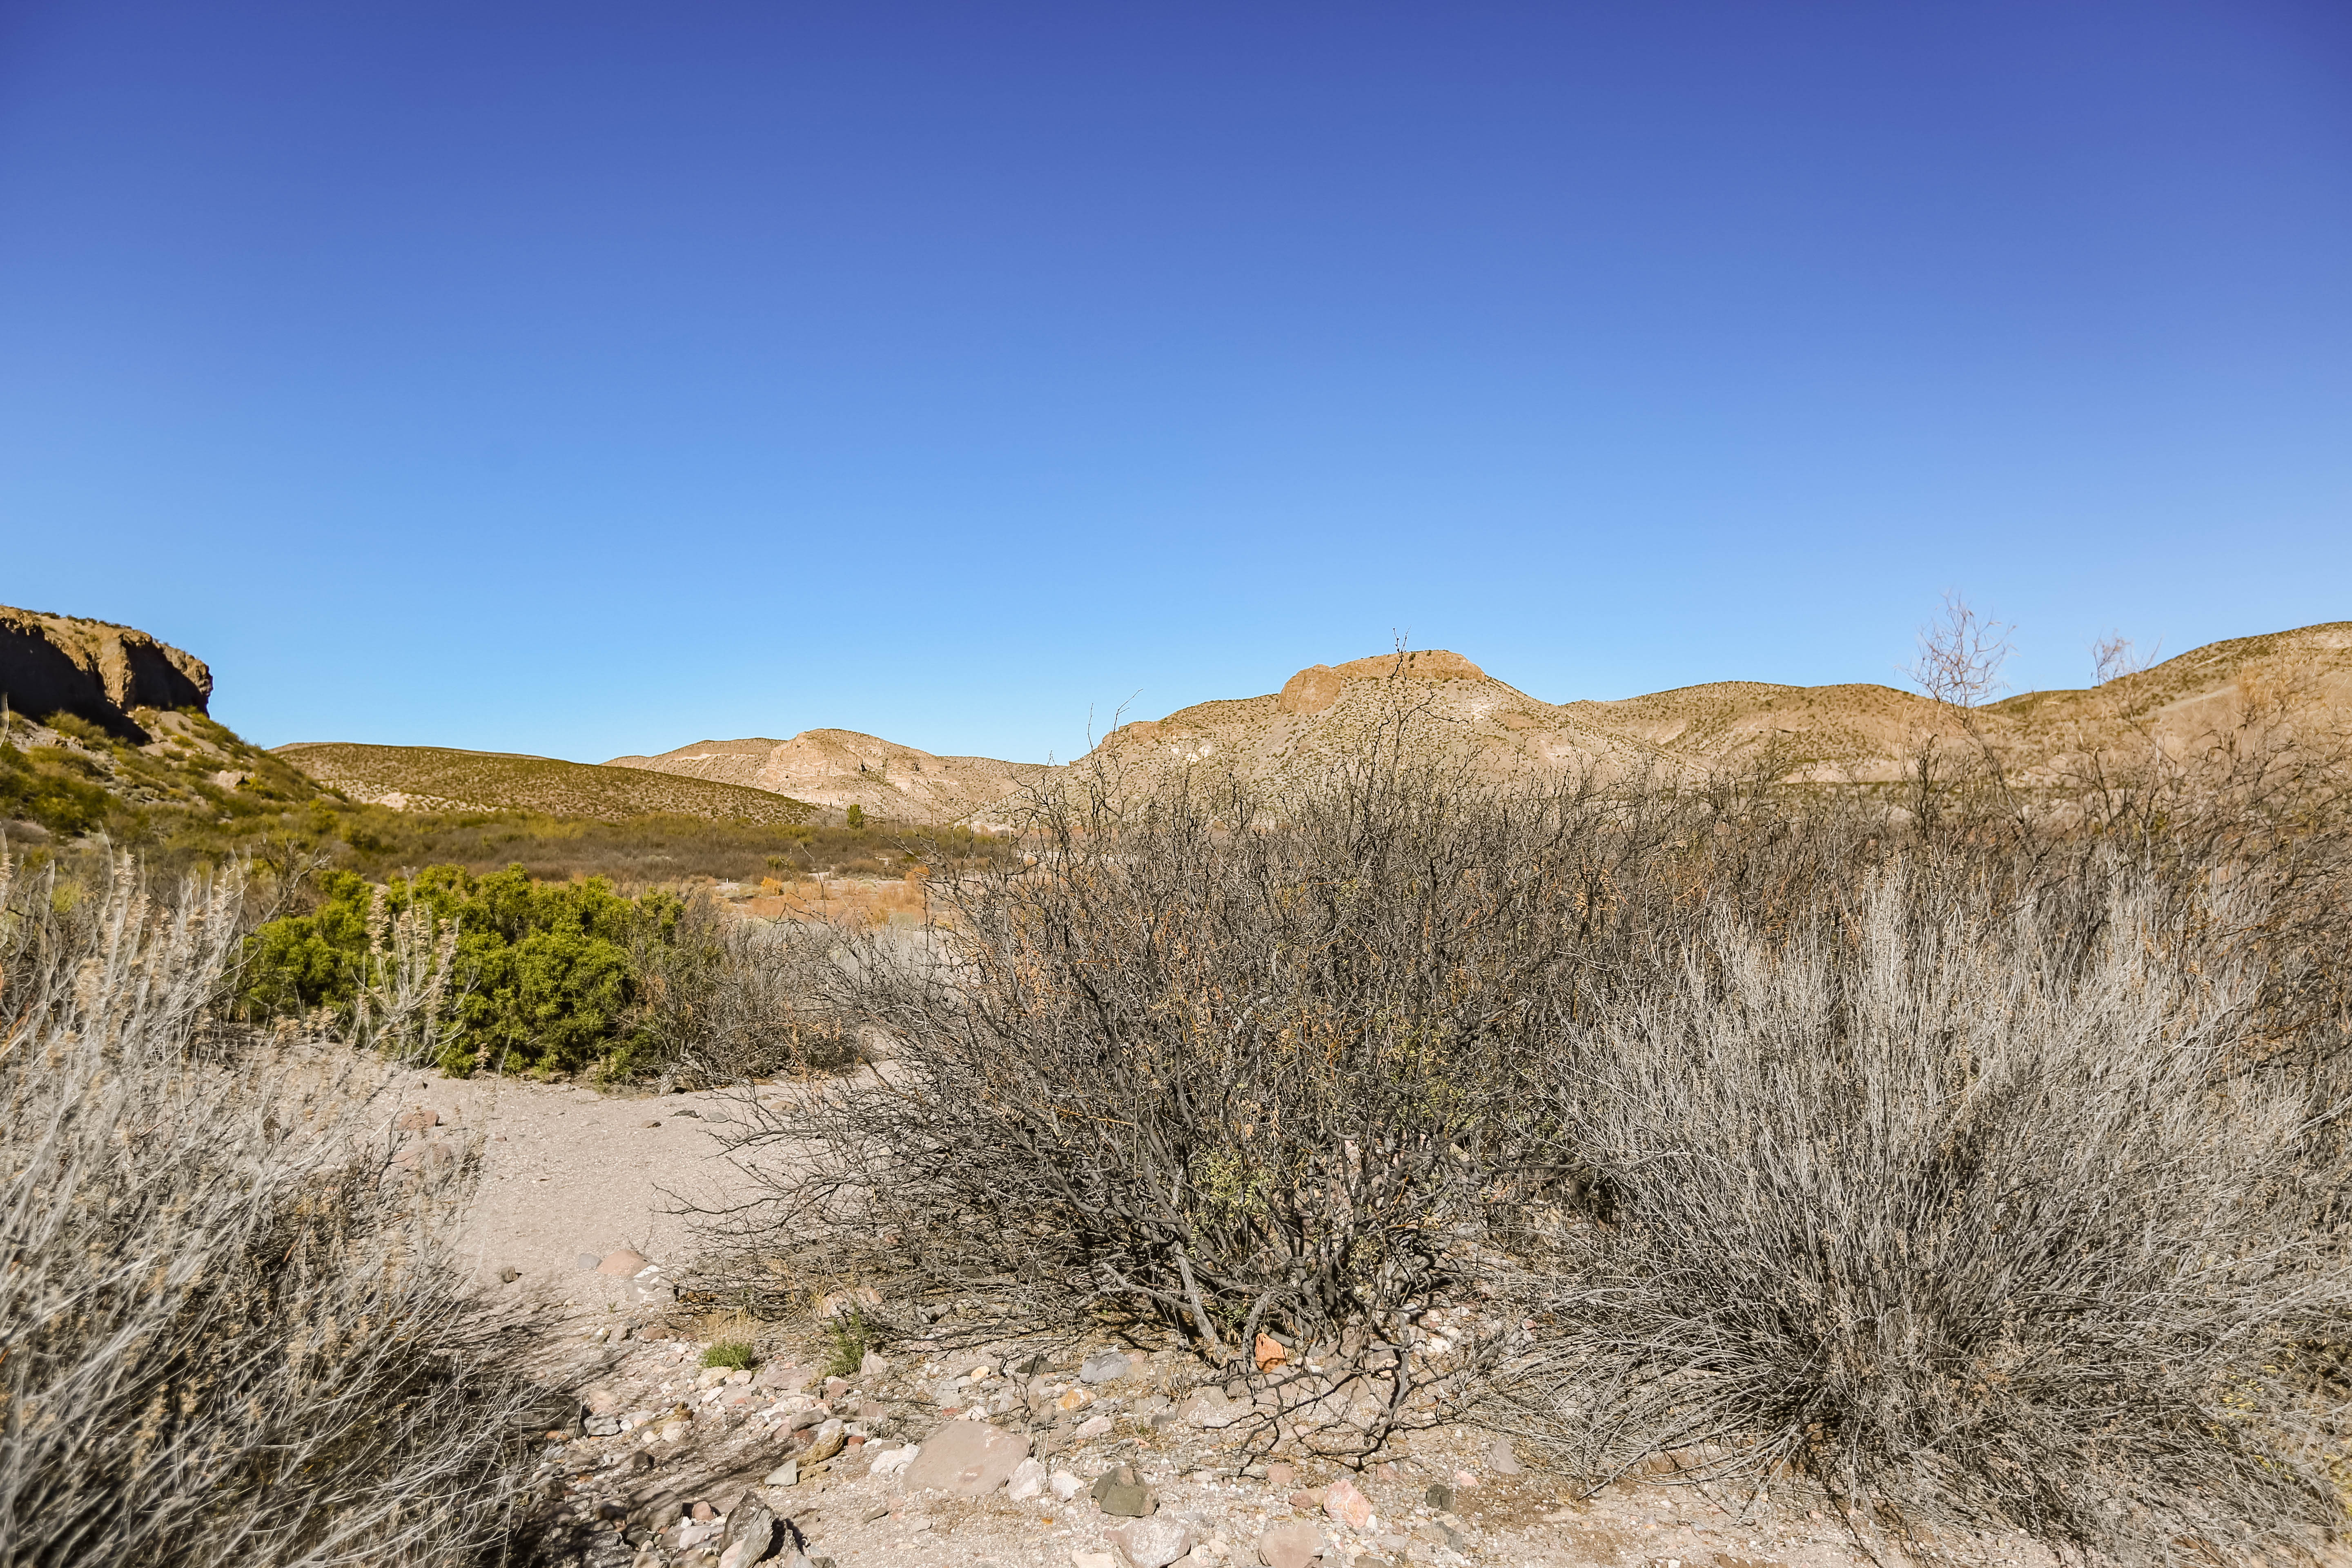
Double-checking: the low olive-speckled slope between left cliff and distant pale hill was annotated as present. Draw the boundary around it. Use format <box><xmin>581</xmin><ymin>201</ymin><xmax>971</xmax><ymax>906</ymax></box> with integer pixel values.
<box><xmin>273</xmin><ymin>740</ymin><xmax>816</xmax><ymax>825</ymax></box>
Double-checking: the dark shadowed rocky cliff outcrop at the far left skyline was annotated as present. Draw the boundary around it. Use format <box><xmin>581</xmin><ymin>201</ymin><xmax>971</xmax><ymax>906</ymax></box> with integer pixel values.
<box><xmin>0</xmin><ymin>604</ymin><xmax>212</xmax><ymax>745</ymax></box>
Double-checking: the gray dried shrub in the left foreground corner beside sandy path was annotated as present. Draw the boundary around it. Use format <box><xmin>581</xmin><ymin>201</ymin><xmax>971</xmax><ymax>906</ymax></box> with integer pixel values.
<box><xmin>0</xmin><ymin>858</ymin><xmax>539</xmax><ymax>1568</ymax></box>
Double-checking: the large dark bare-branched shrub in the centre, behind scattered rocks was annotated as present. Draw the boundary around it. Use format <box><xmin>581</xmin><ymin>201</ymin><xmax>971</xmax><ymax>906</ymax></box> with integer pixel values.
<box><xmin>686</xmin><ymin>750</ymin><xmax>1703</xmax><ymax>1448</ymax></box>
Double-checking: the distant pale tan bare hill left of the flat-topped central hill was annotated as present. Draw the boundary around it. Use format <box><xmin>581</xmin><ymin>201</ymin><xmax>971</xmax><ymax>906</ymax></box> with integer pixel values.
<box><xmin>604</xmin><ymin>729</ymin><xmax>1047</xmax><ymax>823</ymax></box>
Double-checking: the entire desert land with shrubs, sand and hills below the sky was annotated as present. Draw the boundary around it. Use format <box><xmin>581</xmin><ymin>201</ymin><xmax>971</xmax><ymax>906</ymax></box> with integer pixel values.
<box><xmin>13</xmin><ymin>597</ymin><xmax>2352</xmax><ymax>1568</ymax></box>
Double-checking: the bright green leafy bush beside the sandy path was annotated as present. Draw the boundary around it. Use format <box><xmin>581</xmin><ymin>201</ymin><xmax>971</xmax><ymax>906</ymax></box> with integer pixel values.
<box><xmin>245</xmin><ymin>865</ymin><xmax>684</xmax><ymax>1074</ymax></box>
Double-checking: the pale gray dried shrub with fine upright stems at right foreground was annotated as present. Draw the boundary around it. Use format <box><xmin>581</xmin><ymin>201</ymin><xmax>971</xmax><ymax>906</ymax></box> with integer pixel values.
<box><xmin>1510</xmin><ymin>856</ymin><xmax>2352</xmax><ymax>1561</ymax></box>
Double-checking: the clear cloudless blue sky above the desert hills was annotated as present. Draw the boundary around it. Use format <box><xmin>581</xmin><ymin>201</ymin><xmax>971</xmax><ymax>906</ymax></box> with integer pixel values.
<box><xmin>0</xmin><ymin>0</ymin><xmax>2352</xmax><ymax>760</ymax></box>
